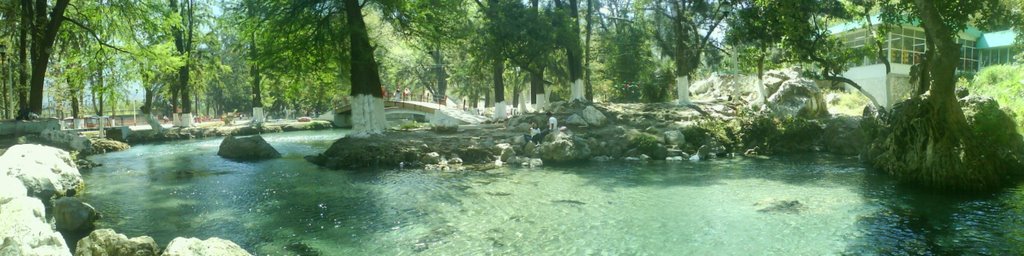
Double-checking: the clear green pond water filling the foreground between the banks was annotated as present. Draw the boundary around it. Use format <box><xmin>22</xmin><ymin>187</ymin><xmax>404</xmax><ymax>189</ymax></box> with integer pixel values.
<box><xmin>83</xmin><ymin>130</ymin><xmax>1024</xmax><ymax>255</ymax></box>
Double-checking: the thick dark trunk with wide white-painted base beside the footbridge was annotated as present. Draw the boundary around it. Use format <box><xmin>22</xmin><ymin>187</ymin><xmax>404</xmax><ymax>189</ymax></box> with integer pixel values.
<box><xmin>344</xmin><ymin>0</ymin><xmax>386</xmax><ymax>136</ymax></box>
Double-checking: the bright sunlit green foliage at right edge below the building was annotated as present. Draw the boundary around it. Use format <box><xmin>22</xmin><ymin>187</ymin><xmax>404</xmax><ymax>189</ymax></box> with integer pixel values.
<box><xmin>967</xmin><ymin>65</ymin><xmax>1024</xmax><ymax>133</ymax></box>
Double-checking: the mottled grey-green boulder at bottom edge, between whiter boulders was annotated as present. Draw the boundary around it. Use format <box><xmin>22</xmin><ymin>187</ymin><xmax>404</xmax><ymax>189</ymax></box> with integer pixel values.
<box><xmin>75</xmin><ymin>228</ymin><xmax>160</xmax><ymax>256</ymax></box>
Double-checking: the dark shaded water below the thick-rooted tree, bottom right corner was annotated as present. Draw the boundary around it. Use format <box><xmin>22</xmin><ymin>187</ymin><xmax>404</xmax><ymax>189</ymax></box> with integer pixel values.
<box><xmin>846</xmin><ymin>168</ymin><xmax>1024</xmax><ymax>255</ymax></box>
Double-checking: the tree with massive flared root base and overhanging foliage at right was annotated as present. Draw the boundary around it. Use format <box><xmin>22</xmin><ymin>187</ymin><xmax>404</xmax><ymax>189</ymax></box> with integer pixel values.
<box><xmin>748</xmin><ymin>0</ymin><xmax>1021</xmax><ymax>190</ymax></box>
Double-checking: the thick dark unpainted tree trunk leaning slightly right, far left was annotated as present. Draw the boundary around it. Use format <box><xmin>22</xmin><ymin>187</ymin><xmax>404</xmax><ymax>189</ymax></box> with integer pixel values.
<box><xmin>29</xmin><ymin>0</ymin><xmax>69</xmax><ymax>115</ymax></box>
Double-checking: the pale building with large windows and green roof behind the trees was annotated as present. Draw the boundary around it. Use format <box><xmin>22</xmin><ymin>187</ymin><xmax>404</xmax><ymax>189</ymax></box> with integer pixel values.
<box><xmin>829</xmin><ymin>17</ymin><xmax>1021</xmax><ymax>108</ymax></box>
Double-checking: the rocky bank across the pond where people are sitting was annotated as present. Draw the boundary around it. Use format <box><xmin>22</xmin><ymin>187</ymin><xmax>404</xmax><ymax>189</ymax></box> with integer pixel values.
<box><xmin>307</xmin><ymin>100</ymin><xmax>863</xmax><ymax>170</ymax></box>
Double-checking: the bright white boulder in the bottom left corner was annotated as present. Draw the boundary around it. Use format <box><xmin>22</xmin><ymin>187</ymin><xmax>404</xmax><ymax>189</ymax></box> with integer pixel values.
<box><xmin>0</xmin><ymin>196</ymin><xmax>71</xmax><ymax>256</ymax></box>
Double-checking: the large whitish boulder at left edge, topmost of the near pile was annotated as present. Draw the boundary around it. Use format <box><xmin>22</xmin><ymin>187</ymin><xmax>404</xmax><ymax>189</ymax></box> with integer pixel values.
<box><xmin>0</xmin><ymin>144</ymin><xmax>83</xmax><ymax>202</ymax></box>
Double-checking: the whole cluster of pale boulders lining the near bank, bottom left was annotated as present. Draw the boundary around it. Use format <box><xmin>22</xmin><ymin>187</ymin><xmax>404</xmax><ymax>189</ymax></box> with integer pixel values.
<box><xmin>0</xmin><ymin>144</ymin><xmax>250</xmax><ymax>256</ymax></box>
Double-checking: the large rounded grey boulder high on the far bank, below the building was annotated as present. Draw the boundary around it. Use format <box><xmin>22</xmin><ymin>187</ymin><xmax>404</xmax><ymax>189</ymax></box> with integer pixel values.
<box><xmin>768</xmin><ymin>78</ymin><xmax>828</xmax><ymax>119</ymax></box>
